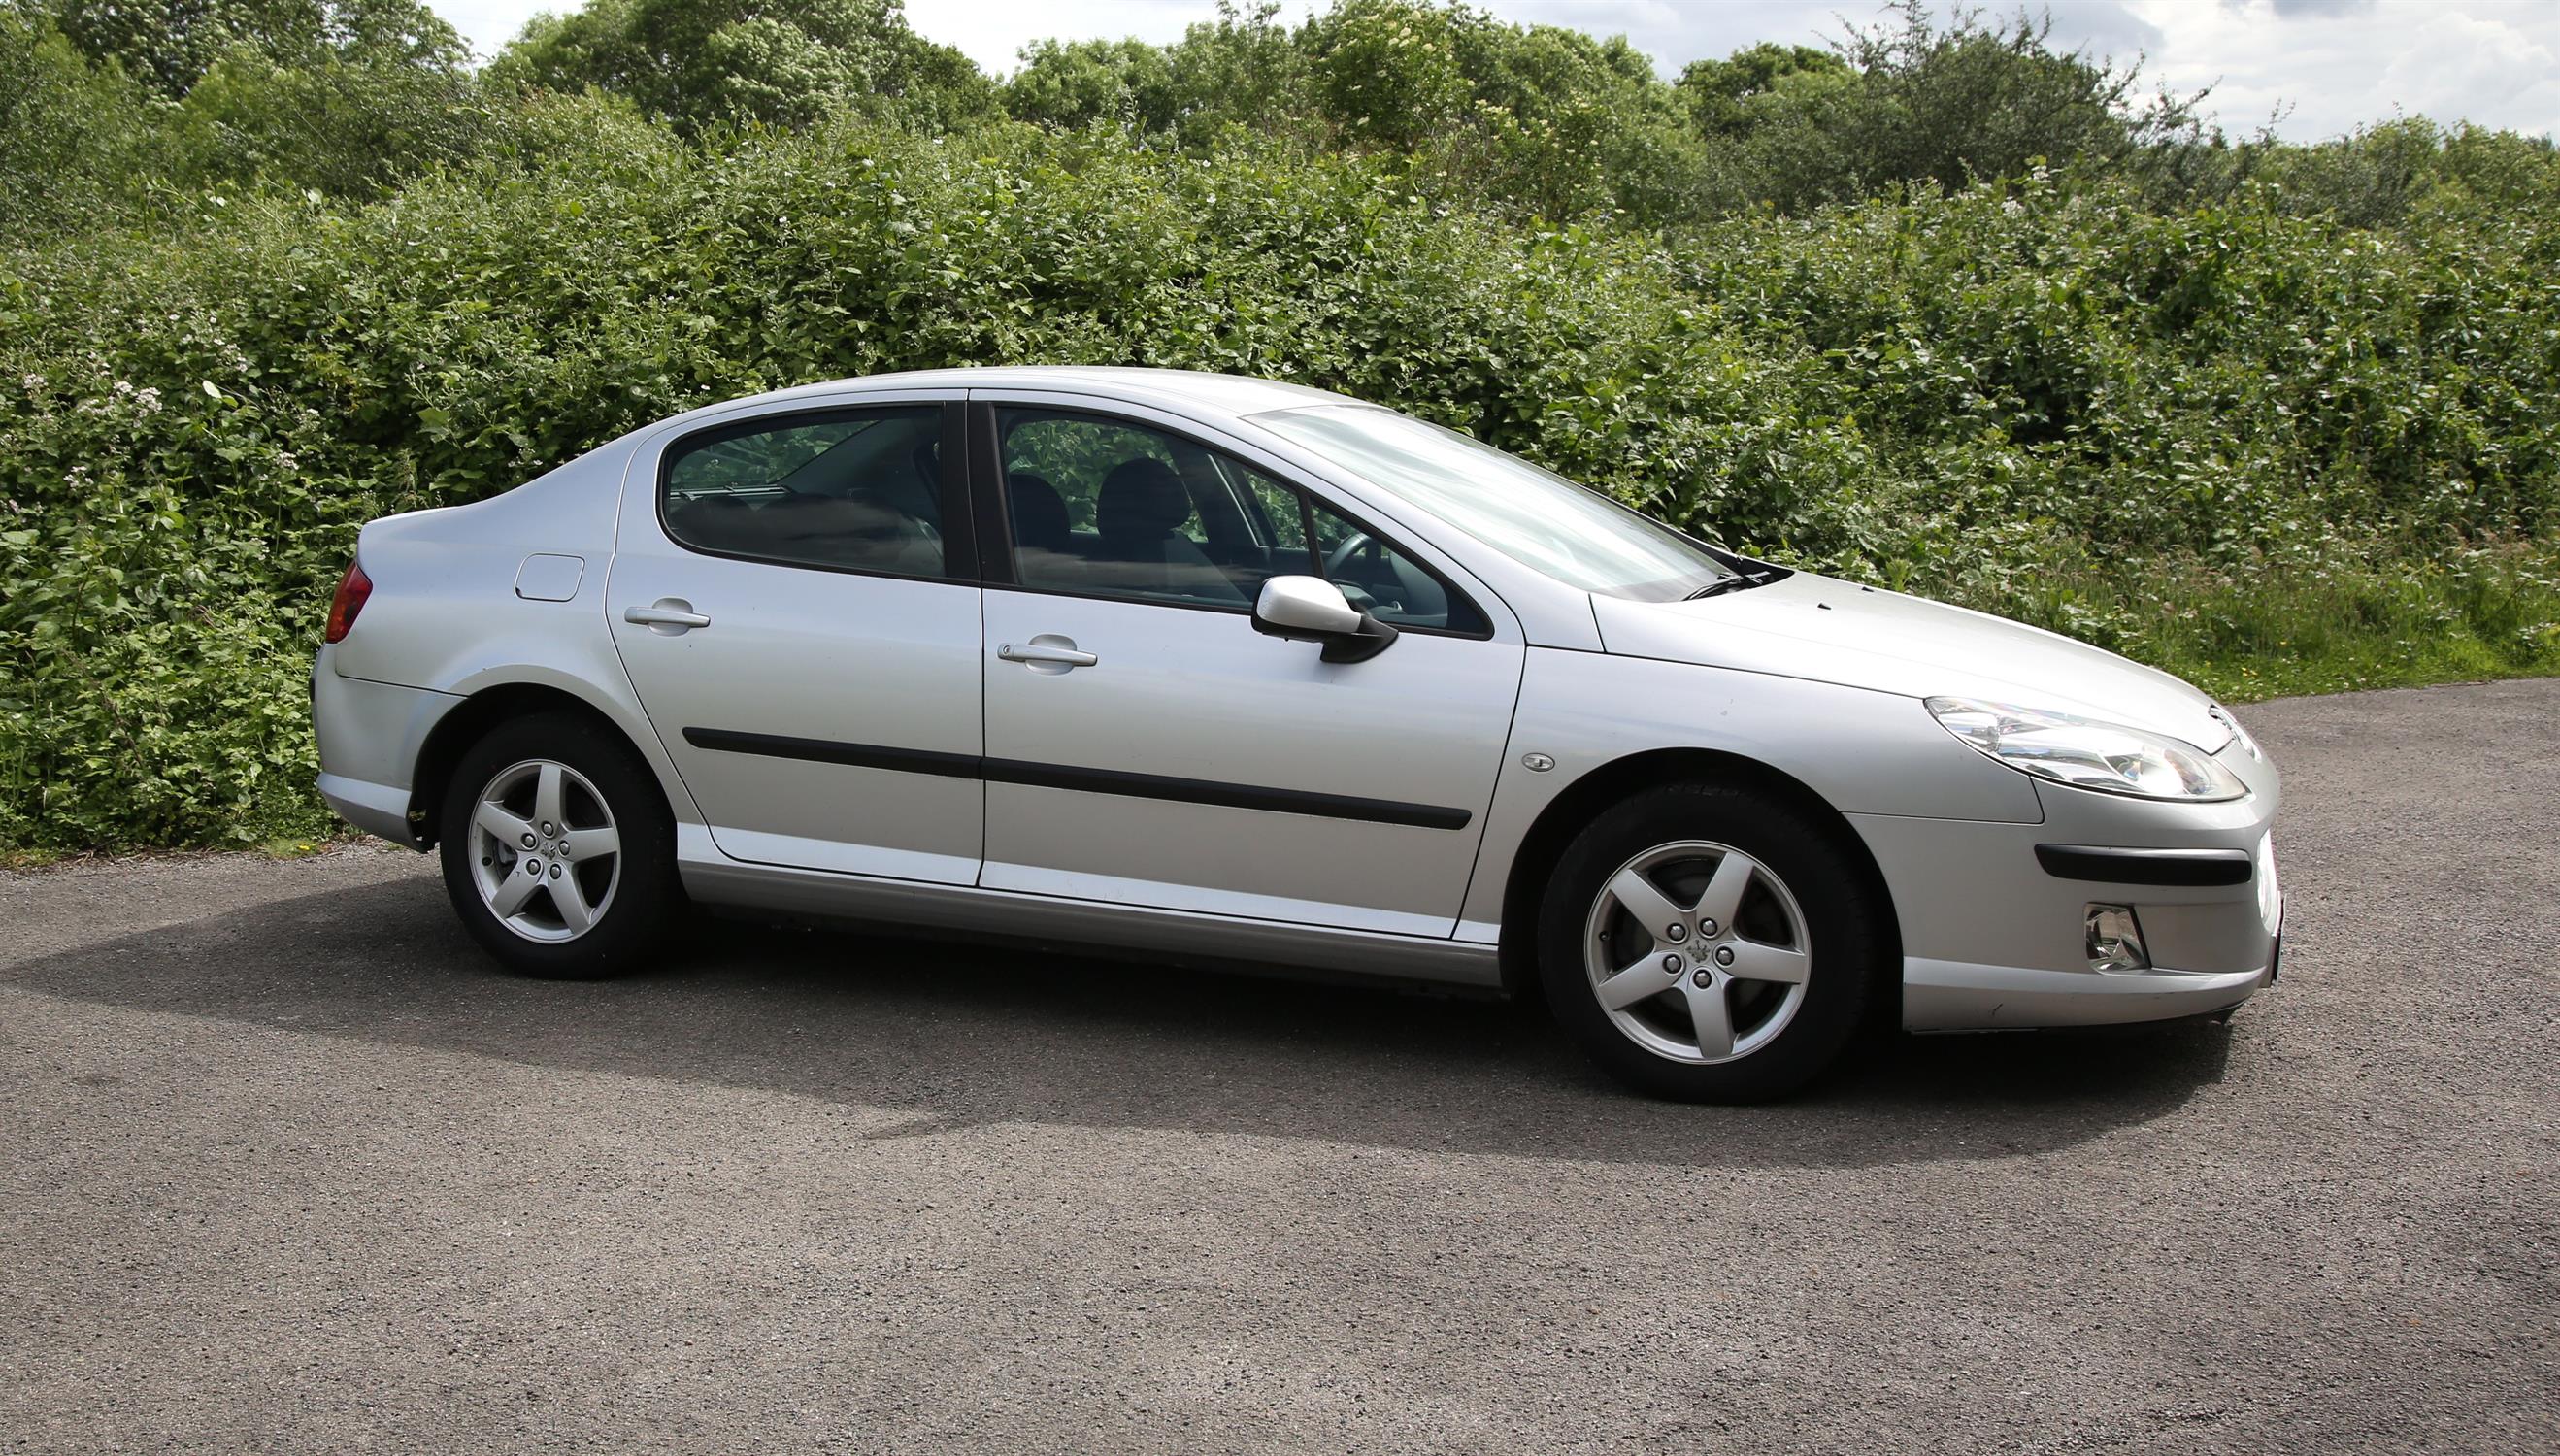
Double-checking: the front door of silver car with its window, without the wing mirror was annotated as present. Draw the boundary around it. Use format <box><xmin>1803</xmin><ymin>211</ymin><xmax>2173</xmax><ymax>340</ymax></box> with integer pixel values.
<box><xmin>981</xmin><ymin>405</ymin><xmax>1523</xmax><ymax>937</ymax></box>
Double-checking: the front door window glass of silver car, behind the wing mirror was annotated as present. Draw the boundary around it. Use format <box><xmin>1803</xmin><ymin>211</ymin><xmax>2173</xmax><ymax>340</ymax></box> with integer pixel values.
<box><xmin>996</xmin><ymin>410</ymin><xmax>1490</xmax><ymax>635</ymax></box>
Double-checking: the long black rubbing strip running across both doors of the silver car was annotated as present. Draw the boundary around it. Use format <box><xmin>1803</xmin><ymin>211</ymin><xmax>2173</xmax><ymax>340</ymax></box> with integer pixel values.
<box><xmin>683</xmin><ymin>729</ymin><xmax>1475</xmax><ymax>829</ymax></box>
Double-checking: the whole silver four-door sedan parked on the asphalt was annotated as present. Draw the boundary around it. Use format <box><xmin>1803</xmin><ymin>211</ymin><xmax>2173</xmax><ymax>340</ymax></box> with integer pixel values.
<box><xmin>313</xmin><ymin>369</ymin><xmax>2283</xmax><ymax>1101</ymax></box>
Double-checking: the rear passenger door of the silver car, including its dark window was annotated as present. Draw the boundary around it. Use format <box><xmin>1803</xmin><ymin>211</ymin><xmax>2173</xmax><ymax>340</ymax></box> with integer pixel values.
<box><xmin>607</xmin><ymin>391</ymin><xmax>985</xmax><ymax>882</ymax></box>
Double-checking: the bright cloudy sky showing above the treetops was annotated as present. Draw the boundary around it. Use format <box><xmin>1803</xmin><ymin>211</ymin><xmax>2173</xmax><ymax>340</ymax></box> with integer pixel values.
<box><xmin>430</xmin><ymin>0</ymin><xmax>2560</xmax><ymax>141</ymax></box>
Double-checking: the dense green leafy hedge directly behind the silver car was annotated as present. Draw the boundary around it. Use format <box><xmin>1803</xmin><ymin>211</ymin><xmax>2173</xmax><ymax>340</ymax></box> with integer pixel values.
<box><xmin>0</xmin><ymin>121</ymin><xmax>2560</xmax><ymax>849</ymax></box>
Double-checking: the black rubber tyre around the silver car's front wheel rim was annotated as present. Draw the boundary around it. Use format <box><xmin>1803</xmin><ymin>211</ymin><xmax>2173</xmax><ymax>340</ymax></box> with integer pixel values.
<box><xmin>1539</xmin><ymin>783</ymin><xmax>1892</xmax><ymax>1103</ymax></box>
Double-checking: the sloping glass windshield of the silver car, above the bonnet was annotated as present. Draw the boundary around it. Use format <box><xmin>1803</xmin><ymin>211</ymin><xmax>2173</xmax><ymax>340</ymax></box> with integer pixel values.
<box><xmin>1254</xmin><ymin>405</ymin><xmax>1733</xmax><ymax>602</ymax></box>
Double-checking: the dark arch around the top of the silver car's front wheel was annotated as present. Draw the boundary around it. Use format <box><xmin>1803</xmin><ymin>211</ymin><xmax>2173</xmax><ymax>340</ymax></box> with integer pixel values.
<box><xmin>1498</xmin><ymin>747</ymin><xmax>1902</xmax><ymax>1008</ymax></box>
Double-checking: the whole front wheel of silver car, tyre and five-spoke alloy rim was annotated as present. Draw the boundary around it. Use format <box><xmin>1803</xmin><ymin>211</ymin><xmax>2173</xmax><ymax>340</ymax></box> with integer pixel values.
<box><xmin>1539</xmin><ymin>783</ymin><xmax>1886</xmax><ymax>1103</ymax></box>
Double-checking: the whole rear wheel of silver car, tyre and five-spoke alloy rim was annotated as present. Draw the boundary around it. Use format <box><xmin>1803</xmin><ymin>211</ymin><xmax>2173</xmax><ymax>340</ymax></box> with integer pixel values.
<box><xmin>438</xmin><ymin>714</ymin><xmax>681</xmax><ymax>977</ymax></box>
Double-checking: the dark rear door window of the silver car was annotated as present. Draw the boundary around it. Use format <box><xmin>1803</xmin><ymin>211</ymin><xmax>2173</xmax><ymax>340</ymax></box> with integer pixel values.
<box><xmin>658</xmin><ymin>405</ymin><xmax>949</xmax><ymax>576</ymax></box>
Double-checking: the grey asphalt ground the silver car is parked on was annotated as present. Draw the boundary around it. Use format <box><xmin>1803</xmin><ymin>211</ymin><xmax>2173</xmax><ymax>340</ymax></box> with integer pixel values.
<box><xmin>0</xmin><ymin>680</ymin><xmax>2560</xmax><ymax>1453</ymax></box>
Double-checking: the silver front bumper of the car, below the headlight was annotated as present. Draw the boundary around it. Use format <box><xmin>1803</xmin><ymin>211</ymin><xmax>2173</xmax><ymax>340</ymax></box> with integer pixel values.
<box><xmin>1851</xmin><ymin>745</ymin><xmax>2283</xmax><ymax>1031</ymax></box>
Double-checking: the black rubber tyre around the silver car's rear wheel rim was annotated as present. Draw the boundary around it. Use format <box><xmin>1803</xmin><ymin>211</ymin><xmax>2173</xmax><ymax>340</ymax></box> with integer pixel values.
<box><xmin>435</xmin><ymin>714</ymin><xmax>683</xmax><ymax>980</ymax></box>
